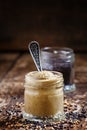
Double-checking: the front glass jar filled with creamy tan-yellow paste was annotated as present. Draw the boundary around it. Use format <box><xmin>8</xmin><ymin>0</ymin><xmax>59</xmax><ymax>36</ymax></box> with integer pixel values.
<box><xmin>23</xmin><ymin>71</ymin><xmax>64</xmax><ymax>121</ymax></box>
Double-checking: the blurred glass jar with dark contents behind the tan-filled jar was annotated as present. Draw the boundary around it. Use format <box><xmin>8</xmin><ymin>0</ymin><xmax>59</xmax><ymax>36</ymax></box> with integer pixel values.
<box><xmin>41</xmin><ymin>47</ymin><xmax>76</xmax><ymax>92</ymax></box>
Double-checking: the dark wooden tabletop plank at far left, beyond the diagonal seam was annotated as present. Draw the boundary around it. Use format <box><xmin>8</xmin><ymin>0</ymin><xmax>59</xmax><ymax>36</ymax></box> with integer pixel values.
<box><xmin>0</xmin><ymin>53</ymin><xmax>18</xmax><ymax>81</ymax></box>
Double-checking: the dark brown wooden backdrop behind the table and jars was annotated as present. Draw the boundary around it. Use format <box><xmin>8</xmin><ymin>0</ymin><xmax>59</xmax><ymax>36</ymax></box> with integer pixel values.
<box><xmin>0</xmin><ymin>0</ymin><xmax>87</xmax><ymax>51</ymax></box>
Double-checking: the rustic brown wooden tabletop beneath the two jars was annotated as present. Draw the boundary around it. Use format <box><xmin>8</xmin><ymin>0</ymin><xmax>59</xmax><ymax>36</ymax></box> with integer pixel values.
<box><xmin>0</xmin><ymin>53</ymin><xmax>87</xmax><ymax>130</ymax></box>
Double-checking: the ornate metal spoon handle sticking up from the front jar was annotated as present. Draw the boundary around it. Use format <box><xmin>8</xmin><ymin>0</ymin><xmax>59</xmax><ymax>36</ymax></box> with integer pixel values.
<box><xmin>28</xmin><ymin>41</ymin><xmax>42</xmax><ymax>71</ymax></box>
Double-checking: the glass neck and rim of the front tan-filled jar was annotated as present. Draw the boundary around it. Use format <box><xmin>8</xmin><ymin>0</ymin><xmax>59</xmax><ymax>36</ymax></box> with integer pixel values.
<box><xmin>25</xmin><ymin>71</ymin><xmax>63</xmax><ymax>88</ymax></box>
